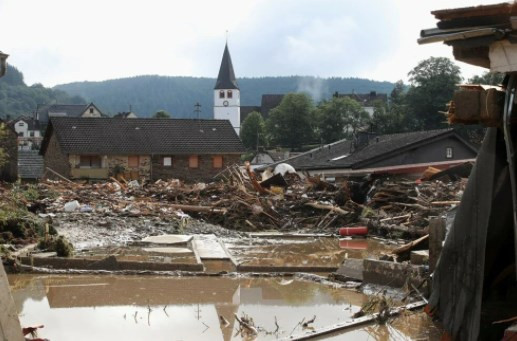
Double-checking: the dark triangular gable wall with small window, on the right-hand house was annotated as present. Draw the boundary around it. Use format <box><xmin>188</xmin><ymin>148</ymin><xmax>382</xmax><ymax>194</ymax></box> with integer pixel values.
<box><xmin>361</xmin><ymin>136</ymin><xmax>477</xmax><ymax>168</ymax></box>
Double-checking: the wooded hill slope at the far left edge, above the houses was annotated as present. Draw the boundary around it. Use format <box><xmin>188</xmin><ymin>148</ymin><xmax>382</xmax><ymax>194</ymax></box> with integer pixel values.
<box><xmin>0</xmin><ymin>65</ymin><xmax>86</xmax><ymax>118</ymax></box>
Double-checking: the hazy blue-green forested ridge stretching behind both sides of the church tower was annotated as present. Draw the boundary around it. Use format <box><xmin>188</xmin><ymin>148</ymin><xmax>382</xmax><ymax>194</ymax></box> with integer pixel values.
<box><xmin>55</xmin><ymin>76</ymin><xmax>394</xmax><ymax>118</ymax></box>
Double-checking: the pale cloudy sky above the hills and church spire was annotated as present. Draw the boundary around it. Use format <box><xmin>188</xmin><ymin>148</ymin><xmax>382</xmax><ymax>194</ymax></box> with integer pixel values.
<box><xmin>0</xmin><ymin>0</ymin><xmax>502</xmax><ymax>86</ymax></box>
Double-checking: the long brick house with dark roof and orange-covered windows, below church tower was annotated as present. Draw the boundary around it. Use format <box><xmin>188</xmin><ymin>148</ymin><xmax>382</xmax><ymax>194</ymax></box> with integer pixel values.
<box><xmin>40</xmin><ymin>117</ymin><xmax>245</xmax><ymax>181</ymax></box>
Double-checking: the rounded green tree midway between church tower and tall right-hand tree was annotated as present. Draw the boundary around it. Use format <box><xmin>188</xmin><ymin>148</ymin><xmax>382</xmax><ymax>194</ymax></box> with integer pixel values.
<box><xmin>317</xmin><ymin>97</ymin><xmax>369</xmax><ymax>143</ymax></box>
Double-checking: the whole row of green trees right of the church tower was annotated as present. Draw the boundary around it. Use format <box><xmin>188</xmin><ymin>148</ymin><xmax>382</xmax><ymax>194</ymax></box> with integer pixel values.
<box><xmin>240</xmin><ymin>57</ymin><xmax>502</xmax><ymax>150</ymax></box>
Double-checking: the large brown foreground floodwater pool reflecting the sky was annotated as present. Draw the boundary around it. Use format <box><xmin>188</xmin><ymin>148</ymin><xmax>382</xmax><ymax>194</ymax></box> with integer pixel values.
<box><xmin>9</xmin><ymin>275</ymin><xmax>438</xmax><ymax>341</ymax></box>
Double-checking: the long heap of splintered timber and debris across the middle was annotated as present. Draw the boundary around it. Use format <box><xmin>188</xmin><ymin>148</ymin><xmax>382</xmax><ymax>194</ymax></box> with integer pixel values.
<box><xmin>12</xmin><ymin>167</ymin><xmax>465</xmax><ymax>232</ymax></box>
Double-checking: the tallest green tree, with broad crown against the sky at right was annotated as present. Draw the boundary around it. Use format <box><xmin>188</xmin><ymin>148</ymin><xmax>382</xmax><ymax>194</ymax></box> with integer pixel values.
<box><xmin>406</xmin><ymin>57</ymin><xmax>462</xmax><ymax>130</ymax></box>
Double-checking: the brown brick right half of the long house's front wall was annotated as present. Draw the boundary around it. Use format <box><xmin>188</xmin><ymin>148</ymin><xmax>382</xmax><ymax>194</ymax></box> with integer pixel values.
<box><xmin>152</xmin><ymin>154</ymin><xmax>240</xmax><ymax>182</ymax></box>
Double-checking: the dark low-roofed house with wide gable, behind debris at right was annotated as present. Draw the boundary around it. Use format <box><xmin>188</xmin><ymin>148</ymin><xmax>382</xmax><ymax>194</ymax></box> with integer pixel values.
<box><xmin>263</xmin><ymin>129</ymin><xmax>477</xmax><ymax>180</ymax></box>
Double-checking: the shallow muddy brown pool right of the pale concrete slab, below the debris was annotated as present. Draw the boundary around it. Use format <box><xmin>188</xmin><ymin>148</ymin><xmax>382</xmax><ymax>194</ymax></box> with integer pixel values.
<box><xmin>225</xmin><ymin>238</ymin><xmax>393</xmax><ymax>267</ymax></box>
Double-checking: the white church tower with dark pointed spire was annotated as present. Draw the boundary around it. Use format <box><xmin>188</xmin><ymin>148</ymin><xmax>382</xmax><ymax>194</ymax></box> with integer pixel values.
<box><xmin>214</xmin><ymin>43</ymin><xmax>241</xmax><ymax>135</ymax></box>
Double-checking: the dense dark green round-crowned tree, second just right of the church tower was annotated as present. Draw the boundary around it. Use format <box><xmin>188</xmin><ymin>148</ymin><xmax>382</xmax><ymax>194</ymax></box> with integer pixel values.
<box><xmin>266</xmin><ymin>93</ymin><xmax>315</xmax><ymax>149</ymax></box>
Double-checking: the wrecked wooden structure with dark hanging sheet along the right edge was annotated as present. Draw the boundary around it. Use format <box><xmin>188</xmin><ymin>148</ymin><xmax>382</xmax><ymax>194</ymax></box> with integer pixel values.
<box><xmin>419</xmin><ymin>3</ymin><xmax>517</xmax><ymax>340</ymax></box>
